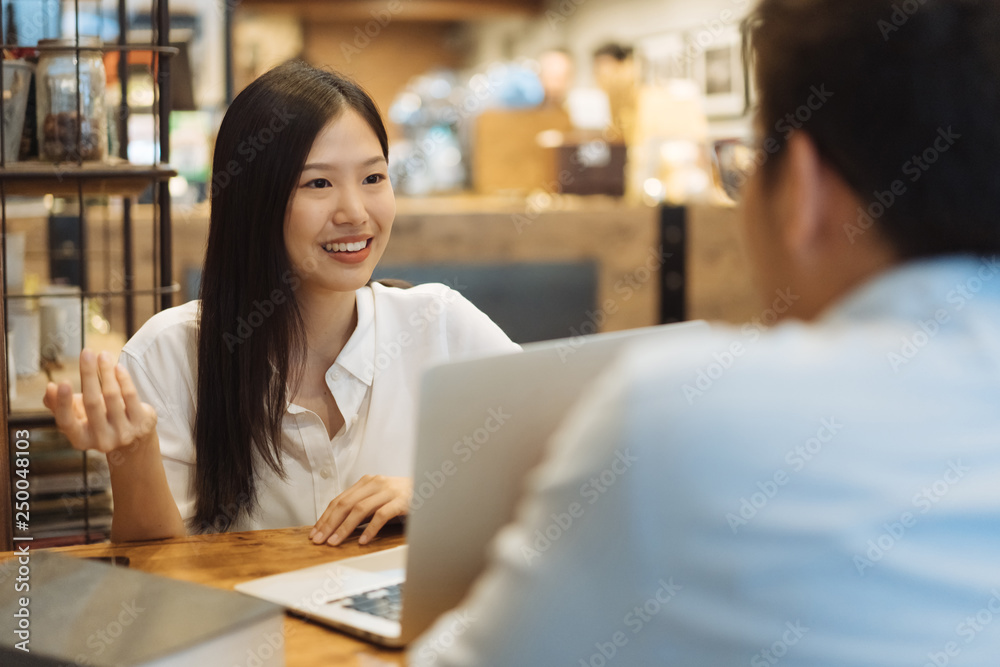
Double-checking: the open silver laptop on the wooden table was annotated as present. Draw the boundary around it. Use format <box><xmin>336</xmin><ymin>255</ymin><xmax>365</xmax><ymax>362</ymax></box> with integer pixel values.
<box><xmin>236</xmin><ymin>322</ymin><xmax>708</xmax><ymax>647</ymax></box>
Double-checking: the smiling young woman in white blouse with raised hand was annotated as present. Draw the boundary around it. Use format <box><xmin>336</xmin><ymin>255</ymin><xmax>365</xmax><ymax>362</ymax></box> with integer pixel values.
<box><xmin>45</xmin><ymin>62</ymin><xmax>518</xmax><ymax>545</ymax></box>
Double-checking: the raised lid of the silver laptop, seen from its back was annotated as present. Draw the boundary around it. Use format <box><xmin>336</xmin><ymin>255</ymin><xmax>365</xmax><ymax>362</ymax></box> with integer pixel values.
<box><xmin>399</xmin><ymin>321</ymin><xmax>709</xmax><ymax>645</ymax></box>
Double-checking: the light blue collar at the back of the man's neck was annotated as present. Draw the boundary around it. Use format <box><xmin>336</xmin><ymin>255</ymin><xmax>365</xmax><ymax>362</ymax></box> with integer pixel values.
<box><xmin>821</xmin><ymin>255</ymin><xmax>1000</xmax><ymax>323</ymax></box>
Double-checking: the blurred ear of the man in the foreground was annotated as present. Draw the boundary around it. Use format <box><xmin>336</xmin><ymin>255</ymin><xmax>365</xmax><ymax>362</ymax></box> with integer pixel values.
<box><xmin>780</xmin><ymin>132</ymin><xmax>831</xmax><ymax>262</ymax></box>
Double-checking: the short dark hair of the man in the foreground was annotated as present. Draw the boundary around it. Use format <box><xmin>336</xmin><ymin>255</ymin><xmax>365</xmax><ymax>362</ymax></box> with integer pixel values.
<box><xmin>745</xmin><ymin>0</ymin><xmax>1000</xmax><ymax>258</ymax></box>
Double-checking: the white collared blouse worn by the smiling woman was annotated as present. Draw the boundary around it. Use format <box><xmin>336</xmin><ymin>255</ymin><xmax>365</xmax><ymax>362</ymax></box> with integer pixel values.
<box><xmin>119</xmin><ymin>283</ymin><xmax>519</xmax><ymax>530</ymax></box>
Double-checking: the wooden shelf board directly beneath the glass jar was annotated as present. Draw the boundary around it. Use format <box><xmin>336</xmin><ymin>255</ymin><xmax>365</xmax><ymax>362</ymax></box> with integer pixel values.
<box><xmin>0</xmin><ymin>159</ymin><xmax>177</xmax><ymax>197</ymax></box>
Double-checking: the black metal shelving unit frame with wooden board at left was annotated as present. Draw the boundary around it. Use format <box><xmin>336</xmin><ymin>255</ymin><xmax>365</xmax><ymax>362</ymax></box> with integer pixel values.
<box><xmin>0</xmin><ymin>0</ymin><xmax>179</xmax><ymax>550</ymax></box>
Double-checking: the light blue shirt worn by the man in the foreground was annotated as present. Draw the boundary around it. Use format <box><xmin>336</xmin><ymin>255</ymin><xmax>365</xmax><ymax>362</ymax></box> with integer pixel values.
<box><xmin>411</xmin><ymin>258</ymin><xmax>1000</xmax><ymax>667</ymax></box>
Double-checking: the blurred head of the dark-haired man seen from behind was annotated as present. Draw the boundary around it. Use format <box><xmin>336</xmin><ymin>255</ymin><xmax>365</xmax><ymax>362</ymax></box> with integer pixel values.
<box><xmin>745</xmin><ymin>0</ymin><xmax>1000</xmax><ymax>318</ymax></box>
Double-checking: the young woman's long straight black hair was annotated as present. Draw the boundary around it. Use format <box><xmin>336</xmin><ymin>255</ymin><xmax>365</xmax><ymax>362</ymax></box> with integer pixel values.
<box><xmin>190</xmin><ymin>61</ymin><xmax>388</xmax><ymax>532</ymax></box>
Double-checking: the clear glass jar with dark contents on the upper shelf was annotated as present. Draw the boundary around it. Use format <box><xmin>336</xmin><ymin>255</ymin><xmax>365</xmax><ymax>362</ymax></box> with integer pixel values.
<box><xmin>36</xmin><ymin>37</ymin><xmax>108</xmax><ymax>162</ymax></box>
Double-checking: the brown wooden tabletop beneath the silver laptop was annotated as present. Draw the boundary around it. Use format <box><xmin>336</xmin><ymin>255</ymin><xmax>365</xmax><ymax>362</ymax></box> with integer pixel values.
<box><xmin>0</xmin><ymin>526</ymin><xmax>406</xmax><ymax>667</ymax></box>
